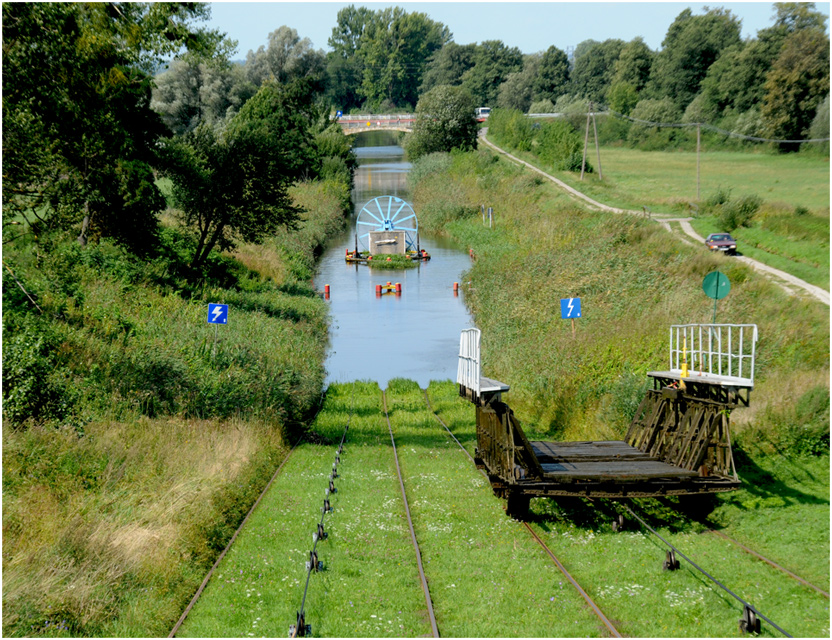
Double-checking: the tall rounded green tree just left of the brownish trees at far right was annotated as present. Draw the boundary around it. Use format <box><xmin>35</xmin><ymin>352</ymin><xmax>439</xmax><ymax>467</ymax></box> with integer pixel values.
<box><xmin>651</xmin><ymin>9</ymin><xmax>741</xmax><ymax>109</ymax></box>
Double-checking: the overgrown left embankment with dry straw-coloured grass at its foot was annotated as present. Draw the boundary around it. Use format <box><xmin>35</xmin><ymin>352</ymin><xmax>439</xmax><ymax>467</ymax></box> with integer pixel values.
<box><xmin>3</xmin><ymin>183</ymin><xmax>344</xmax><ymax>637</ymax></box>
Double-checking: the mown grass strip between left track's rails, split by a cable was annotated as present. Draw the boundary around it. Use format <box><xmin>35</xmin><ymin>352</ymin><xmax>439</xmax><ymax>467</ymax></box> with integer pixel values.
<box><xmin>179</xmin><ymin>383</ymin><xmax>430</xmax><ymax>637</ymax></box>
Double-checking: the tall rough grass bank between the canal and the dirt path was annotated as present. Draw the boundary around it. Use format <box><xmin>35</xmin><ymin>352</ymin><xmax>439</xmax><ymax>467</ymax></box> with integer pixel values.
<box><xmin>414</xmin><ymin>151</ymin><xmax>829</xmax><ymax>446</ymax></box>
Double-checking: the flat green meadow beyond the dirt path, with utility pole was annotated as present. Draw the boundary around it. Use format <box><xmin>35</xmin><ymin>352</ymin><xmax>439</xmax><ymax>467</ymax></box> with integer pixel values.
<box><xmin>484</xmin><ymin>138</ymin><xmax>830</xmax><ymax>291</ymax></box>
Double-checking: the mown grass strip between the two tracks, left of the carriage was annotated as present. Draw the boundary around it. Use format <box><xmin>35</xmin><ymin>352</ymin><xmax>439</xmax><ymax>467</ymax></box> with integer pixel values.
<box><xmin>387</xmin><ymin>380</ymin><xmax>607</xmax><ymax>637</ymax></box>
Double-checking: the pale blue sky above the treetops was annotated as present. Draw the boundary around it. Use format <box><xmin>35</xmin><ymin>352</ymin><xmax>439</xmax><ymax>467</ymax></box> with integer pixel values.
<box><xmin>209</xmin><ymin>0</ymin><xmax>830</xmax><ymax>60</ymax></box>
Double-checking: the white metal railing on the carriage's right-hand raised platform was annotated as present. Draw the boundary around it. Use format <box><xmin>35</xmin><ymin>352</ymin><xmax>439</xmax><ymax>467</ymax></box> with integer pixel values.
<box><xmin>670</xmin><ymin>324</ymin><xmax>757</xmax><ymax>386</ymax></box>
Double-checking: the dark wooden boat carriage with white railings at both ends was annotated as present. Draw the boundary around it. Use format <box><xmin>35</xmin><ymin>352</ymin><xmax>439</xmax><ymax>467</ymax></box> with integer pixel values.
<box><xmin>457</xmin><ymin>324</ymin><xmax>757</xmax><ymax>517</ymax></box>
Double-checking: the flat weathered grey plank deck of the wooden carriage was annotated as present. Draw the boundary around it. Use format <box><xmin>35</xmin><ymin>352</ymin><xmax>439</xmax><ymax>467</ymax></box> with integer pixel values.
<box><xmin>531</xmin><ymin>440</ymin><xmax>697</xmax><ymax>480</ymax></box>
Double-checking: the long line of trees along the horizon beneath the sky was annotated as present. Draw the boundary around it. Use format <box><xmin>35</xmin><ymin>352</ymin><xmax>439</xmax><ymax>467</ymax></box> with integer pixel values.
<box><xmin>153</xmin><ymin>3</ymin><xmax>829</xmax><ymax>145</ymax></box>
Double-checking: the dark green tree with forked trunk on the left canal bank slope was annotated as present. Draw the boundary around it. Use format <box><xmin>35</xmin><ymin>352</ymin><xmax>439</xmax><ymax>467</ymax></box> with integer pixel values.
<box><xmin>161</xmin><ymin>79</ymin><xmax>320</xmax><ymax>269</ymax></box>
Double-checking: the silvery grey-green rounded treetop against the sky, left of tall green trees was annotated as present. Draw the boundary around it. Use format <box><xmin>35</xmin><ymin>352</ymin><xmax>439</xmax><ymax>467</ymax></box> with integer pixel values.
<box><xmin>245</xmin><ymin>26</ymin><xmax>326</xmax><ymax>87</ymax></box>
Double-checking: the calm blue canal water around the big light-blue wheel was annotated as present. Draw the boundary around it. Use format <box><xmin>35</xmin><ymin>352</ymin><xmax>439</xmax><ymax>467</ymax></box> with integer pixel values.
<box><xmin>315</xmin><ymin>132</ymin><xmax>474</xmax><ymax>389</ymax></box>
